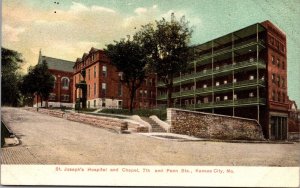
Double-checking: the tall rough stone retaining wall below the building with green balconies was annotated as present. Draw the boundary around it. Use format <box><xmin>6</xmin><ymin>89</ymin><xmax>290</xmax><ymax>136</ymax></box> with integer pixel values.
<box><xmin>167</xmin><ymin>108</ymin><xmax>264</xmax><ymax>140</ymax></box>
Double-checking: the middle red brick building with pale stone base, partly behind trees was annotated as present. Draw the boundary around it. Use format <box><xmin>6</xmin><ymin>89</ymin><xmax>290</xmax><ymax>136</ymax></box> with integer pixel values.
<box><xmin>73</xmin><ymin>48</ymin><xmax>155</xmax><ymax>109</ymax></box>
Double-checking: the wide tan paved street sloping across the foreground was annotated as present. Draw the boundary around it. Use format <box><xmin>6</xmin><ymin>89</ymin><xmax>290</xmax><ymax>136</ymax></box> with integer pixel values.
<box><xmin>1</xmin><ymin>107</ymin><xmax>300</xmax><ymax>166</ymax></box>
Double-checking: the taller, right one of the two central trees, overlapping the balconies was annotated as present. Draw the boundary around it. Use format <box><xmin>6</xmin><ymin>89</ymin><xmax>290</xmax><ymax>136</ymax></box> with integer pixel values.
<box><xmin>134</xmin><ymin>13</ymin><xmax>192</xmax><ymax>107</ymax></box>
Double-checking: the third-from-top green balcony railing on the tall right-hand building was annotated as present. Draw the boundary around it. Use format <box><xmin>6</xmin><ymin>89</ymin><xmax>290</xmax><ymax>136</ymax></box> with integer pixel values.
<box><xmin>157</xmin><ymin>80</ymin><xmax>265</xmax><ymax>100</ymax></box>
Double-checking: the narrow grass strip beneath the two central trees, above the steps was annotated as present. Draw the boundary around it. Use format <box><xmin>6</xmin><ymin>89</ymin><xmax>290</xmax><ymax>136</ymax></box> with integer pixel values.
<box><xmin>100</xmin><ymin>109</ymin><xmax>167</xmax><ymax>121</ymax></box>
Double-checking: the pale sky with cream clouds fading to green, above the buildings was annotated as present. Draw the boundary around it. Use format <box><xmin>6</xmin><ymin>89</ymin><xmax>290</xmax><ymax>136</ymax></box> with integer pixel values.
<box><xmin>2</xmin><ymin>0</ymin><xmax>300</xmax><ymax>106</ymax></box>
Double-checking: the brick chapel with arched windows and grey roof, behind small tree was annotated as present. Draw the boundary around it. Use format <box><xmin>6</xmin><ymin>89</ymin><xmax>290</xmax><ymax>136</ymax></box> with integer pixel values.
<box><xmin>34</xmin><ymin>51</ymin><xmax>74</xmax><ymax>107</ymax></box>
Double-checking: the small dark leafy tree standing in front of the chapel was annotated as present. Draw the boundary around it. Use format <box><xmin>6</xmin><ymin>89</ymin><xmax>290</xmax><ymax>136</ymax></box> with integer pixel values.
<box><xmin>21</xmin><ymin>60</ymin><xmax>54</xmax><ymax>106</ymax></box>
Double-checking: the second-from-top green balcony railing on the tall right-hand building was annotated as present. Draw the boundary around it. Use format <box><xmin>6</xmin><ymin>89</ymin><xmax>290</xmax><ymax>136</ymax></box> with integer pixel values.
<box><xmin>158</xmin><ymin>59</ymin><xmax>266</xmax><ymax>87</ymax></box>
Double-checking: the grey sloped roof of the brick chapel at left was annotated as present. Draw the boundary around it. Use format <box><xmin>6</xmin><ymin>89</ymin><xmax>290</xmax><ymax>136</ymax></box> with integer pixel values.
<box><xmin>39</xmin><ymin>56</ymin><xmax>74</xmax><ymax>72</ymax></box>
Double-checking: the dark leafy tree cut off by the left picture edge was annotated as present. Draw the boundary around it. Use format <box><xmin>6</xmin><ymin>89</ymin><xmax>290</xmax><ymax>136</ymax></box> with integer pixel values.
<box><xmin>1</xmin><ymin>47</ymin><xmax>23</xmax><ymax>106</ymax></box>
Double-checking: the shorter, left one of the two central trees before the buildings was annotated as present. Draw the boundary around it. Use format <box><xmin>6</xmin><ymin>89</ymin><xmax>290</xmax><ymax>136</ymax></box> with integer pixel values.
<box><xmin>105</xmin><ymin>37</ymin><xmax>147</xmax><ymax>113</ymax></box>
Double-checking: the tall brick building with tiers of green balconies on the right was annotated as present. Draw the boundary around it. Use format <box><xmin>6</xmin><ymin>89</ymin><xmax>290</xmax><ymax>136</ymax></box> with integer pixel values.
<box><xmin>157</xmin><ymin>21</ymin><xmax>289</xmax><ymax>139</ymax></box>
